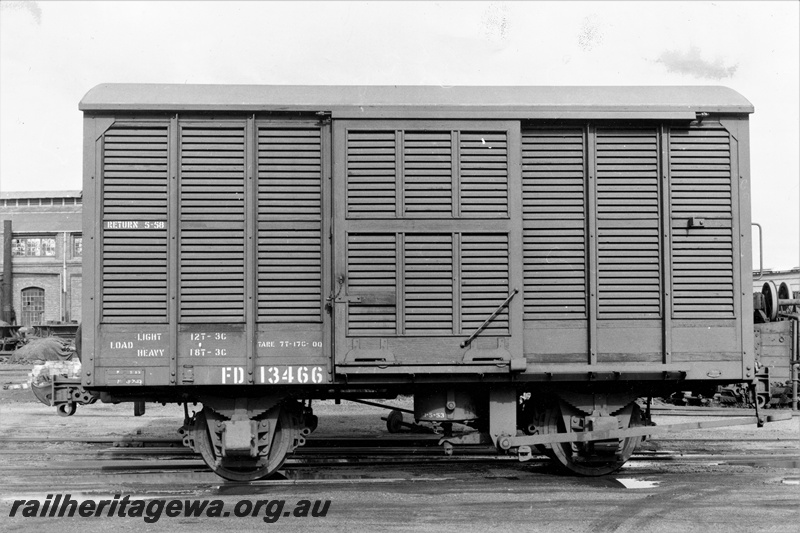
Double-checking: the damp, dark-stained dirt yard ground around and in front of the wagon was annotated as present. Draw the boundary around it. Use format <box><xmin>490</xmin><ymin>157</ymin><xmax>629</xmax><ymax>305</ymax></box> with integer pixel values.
<box><xmin>0</xmin><ymin>365</ymin><xmax>800</xmax><ymax>533</ymax></box>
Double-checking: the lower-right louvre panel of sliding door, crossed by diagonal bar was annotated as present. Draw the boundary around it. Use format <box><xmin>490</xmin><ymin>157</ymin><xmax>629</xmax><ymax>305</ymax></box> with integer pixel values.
<box><xmin>461</xmin><ymin>233</ymin><xmax>510</xmax><ymax>335</ymax></box>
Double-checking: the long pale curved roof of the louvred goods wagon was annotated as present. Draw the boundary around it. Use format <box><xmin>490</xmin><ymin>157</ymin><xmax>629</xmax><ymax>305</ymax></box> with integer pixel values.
<box><xmin>79</xmin><ymin>83</ymin><xmax>753</xmax><ymax>117</ymax></box>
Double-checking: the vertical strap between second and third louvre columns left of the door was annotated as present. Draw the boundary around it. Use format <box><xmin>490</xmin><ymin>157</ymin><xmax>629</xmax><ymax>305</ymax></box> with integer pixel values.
<box><xmin>244</xmin><ymin>115</ymin><xmax>258</xmax><ymax>385</ymax></box>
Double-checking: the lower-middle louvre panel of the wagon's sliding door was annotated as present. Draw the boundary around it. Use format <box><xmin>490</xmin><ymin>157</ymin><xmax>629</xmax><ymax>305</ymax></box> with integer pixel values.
<box><xmin>403</xmin><ymin>233</ymin><xmax>453</xmax><ymax>335</ymax></box>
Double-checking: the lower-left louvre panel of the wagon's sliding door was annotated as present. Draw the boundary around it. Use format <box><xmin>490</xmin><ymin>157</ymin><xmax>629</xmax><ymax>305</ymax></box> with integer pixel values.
<box><xmin>347</xmin><ymin>233</ymin><xmax>397</xmax><ymax>335</ymax></box>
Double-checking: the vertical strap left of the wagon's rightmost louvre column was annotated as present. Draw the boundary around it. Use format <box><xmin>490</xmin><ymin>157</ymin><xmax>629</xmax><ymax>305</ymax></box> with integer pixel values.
<box><xmin>658</xmin><ymin>124</ymin><xmax>674</xmax><ymax>365</ymax></box>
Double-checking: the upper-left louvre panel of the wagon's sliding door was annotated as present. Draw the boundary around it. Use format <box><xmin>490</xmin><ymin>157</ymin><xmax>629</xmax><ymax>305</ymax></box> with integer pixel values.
<box><xmin>347</xmin><ymin>130</ymin><xmax>397</xmax><ymax>217</ymax></box>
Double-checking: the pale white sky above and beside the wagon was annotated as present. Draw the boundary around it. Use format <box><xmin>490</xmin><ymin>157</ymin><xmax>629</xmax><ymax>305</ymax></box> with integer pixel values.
<box><xmin>0</xmin><ymin>0</ymin><xmax>800</xmax><ymax>269</ymax></box>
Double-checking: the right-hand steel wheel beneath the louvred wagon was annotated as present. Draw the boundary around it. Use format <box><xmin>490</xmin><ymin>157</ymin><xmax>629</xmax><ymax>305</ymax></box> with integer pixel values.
<box><xmin>542</xmin><ymin>403</ymin><xmax>642</xmax><ymax>476</ymax></box>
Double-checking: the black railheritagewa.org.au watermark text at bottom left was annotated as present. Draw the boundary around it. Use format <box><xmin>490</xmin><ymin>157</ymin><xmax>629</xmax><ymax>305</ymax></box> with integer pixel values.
<box><xmin>8</xmin><ymin>494</ymin><xmax>331</xmax><ymax>524</ymax></box>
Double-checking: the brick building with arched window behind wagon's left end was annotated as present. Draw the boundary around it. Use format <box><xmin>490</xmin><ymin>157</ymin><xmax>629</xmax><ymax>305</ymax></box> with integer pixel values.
<box><xmin>0</xmin><ymin>191</ymin><xmax>83</xmax><ymax>326</ymax></box>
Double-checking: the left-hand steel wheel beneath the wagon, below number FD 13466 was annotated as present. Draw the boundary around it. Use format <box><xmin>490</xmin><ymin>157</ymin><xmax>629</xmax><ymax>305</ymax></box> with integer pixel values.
<box><xmin>192</xmin><ymin>407</ymin><xmax>299</xmax><ymax>481</ymax></box>
